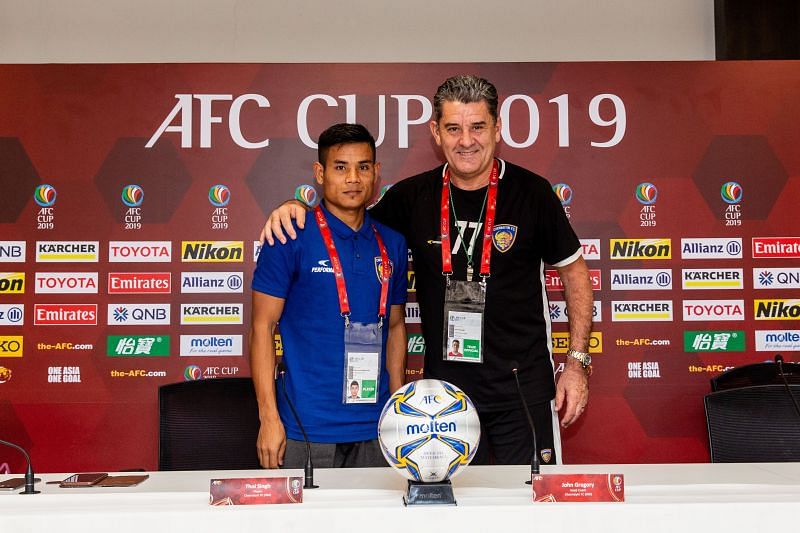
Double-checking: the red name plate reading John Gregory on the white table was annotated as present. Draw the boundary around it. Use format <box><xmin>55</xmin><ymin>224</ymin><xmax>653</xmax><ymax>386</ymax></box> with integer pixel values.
<box><xmin>531</xmin><ymin>474</ymin><xmax>625</xmax><ymax>503</ymax></box>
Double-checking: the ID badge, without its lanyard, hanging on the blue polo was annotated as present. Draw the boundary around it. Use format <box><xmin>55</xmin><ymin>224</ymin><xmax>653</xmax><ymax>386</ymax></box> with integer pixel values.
<box><xmin>342</xmin><ymin>322</ymin><xmax>383</xmax><ymax>404</ymax></box>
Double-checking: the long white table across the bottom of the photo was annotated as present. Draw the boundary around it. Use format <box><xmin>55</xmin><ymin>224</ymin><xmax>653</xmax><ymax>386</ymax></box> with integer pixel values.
<box><xmin>0</xmin><ymin>463</ymin><xmax>800</xmax><ymax>533</ymax></box>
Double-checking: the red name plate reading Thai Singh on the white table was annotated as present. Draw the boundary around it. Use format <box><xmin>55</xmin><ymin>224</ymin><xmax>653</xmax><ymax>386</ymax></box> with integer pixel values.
<box><xmin>209</xmin><ymin>476</ymin><xmax>303</xmax><ymax>505</ymax></box>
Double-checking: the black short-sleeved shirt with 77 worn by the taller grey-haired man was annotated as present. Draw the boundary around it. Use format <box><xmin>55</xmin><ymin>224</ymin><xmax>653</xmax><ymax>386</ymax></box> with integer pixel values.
<box><xmin>370</xmin><ymin>160</ymin><xmax>581</xmax><ymax>411</ymax></box>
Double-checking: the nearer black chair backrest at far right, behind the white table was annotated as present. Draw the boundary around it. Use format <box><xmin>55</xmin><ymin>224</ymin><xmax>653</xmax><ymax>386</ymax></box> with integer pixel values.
<box><xmin>705</xmin><ymin>385</ymin><xmax>800</xmax><ymax>463</ymax></box>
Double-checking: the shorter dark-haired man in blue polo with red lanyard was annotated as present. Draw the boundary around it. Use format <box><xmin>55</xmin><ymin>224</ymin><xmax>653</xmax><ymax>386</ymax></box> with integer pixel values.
<box><xmin>250</xmin><ymin>124</ymin><xmax>408</xmax><ymax>468</ymax></box>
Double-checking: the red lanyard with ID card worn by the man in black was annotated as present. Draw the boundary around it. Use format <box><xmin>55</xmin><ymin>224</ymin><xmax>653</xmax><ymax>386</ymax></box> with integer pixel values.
<box><xmin>439</xmin><ymin>160</ymin><xmax>499</xmax><ymax>363</ymax></box>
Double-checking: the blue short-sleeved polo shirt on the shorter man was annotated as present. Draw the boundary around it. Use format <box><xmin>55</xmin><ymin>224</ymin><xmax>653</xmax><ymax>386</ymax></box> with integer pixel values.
<box><xmin>253</xmin><ymin>205</ymin><xmax>408</xmax><ymax>443</ymax></box>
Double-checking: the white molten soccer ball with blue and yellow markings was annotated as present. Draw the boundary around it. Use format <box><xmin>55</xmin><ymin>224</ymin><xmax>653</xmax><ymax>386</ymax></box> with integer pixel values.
<box><xmin>378</xmin><ymin>379</ymin><xmax>481</xmax><ymax>482</ymax></box>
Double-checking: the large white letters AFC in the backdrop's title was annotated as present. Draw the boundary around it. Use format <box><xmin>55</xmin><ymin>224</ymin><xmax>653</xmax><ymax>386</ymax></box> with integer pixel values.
<box><xmin>145</xmin><ymin>94</ymin><xmax>270</xmax><ymax>150</ymax></box>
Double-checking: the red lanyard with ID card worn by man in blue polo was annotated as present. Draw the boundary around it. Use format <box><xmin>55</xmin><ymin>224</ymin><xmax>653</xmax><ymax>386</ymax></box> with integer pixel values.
<box><xmin>314</xmin><ymin>206</ymin><xmax>391</xmax><ymax>404</ymax></box>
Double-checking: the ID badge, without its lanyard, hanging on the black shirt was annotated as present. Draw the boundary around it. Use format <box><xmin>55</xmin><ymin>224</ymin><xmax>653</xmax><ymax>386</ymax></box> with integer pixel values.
<box><xmin>443</xmin><ymin>280</ymin><xmax>486</xmax><ymax>363</ymax></box>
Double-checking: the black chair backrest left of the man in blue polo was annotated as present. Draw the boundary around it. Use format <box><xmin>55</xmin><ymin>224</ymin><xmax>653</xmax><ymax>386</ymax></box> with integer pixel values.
<box><xmin>158</xmin><ymin>378</ymin><xmax>261</xmax><ymax>470</ymax></box>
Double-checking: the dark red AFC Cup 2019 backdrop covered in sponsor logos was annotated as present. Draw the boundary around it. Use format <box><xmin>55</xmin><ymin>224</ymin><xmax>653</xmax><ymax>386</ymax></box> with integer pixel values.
<box><xmin>0</xmin><ymin>62</ymin><xmax>800</xmax><ymax>471</ymax></box>
